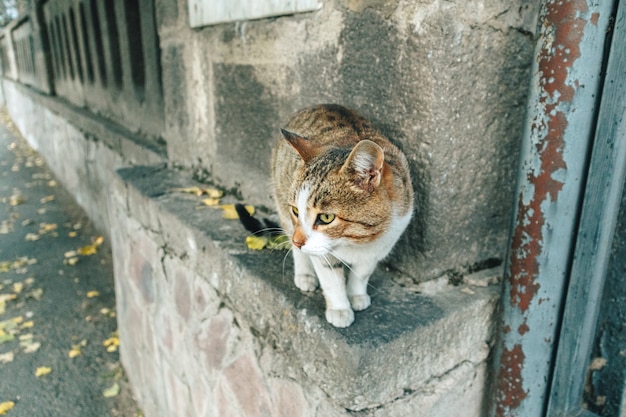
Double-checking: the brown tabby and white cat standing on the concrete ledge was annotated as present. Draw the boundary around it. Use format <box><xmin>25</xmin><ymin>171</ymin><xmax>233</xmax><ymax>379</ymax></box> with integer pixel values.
<box><xmin>271</xmin><ymin>104</ymin><xmax>413</xmax><ymax>327</ymax></box>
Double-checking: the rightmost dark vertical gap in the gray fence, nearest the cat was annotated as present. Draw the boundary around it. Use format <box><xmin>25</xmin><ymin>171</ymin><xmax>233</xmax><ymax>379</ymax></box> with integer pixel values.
<box><xmin>124</xmin><ymin>0</ymin><xmax>146</xmax><ymax>100</ymax></box>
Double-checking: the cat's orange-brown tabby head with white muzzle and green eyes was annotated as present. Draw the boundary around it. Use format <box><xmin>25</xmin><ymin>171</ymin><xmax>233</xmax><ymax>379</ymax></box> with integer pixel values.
<box><xmin>283</xmin><ymin>131</ymin><xmax>392</xmax><ymax>256</ymax></box>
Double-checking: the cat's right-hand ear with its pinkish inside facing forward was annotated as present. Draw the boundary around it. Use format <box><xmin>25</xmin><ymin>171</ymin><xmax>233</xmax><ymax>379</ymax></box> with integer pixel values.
<box><xmin>341</xmin><ymin>140</ymin><xmax>385</xmax><ymax>192</ymax></box>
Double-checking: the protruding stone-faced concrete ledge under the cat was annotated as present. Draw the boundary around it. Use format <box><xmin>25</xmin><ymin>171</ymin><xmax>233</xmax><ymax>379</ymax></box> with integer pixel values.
<box><xmin>110</xmin><ymin>167</ymin><xmax>498</xmax><ymax>417</ymax></box>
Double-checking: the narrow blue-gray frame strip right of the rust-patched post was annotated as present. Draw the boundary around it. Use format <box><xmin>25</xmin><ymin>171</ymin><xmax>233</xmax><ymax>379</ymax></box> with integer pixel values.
<box><xmin>548</xmin><ymin>2</ymin><xmax>626</xmax><ymax>416</ymax></box>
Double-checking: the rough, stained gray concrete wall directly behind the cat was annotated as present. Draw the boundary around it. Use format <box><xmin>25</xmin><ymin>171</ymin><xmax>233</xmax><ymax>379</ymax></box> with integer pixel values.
<box><xmin>156</xmin><ymin>0</ymin><xmax>536</xmax><ymax>281</ymax></box>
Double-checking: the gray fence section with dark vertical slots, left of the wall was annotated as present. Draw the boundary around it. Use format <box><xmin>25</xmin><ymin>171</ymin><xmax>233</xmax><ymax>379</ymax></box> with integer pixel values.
<box><xmin>0</xmin><ymin>0</ymin><xmax>163</xmax><ymax>136</ymax></box>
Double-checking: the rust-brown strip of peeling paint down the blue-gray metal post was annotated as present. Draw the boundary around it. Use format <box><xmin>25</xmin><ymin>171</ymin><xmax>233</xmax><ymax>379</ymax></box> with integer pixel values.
<box><xmin>494</xmin><ymin>0</ymin><xmax>597</xmax><ymax>417</ymax></box>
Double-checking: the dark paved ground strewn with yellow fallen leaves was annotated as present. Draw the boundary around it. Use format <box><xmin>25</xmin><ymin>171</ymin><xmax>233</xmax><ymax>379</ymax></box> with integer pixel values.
<box><xmin>0</xmin><ymin>113</ymin><xmax>141</xmax><ymax>417</ymax></box>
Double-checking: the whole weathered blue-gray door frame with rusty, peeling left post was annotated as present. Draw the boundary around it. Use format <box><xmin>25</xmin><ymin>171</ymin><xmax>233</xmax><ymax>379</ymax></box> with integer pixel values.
<box><xmin>491</xmin><ymin>0</ymin><xmax>626</xmax><ymax>417</ymax></box>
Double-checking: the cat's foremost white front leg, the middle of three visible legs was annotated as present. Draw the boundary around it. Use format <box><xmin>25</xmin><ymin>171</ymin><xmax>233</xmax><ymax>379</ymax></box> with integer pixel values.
<box><xmin>311</xmin><ymin>256</ymin><xmax>354</xmax><ymax>327</ymax></box>
